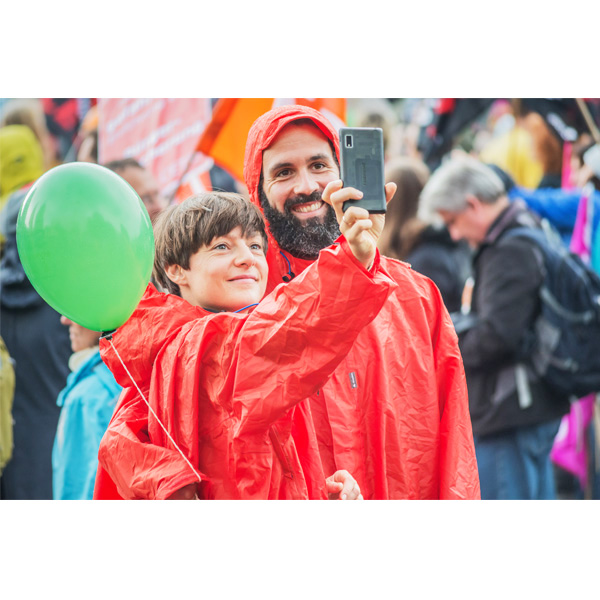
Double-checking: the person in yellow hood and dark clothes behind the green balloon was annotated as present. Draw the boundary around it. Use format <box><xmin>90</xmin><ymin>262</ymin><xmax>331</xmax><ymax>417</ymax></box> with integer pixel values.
<box><xmin>0</xmin><ymin>125</ymin><xmax>71</xmax><ymax>500</ymax></box>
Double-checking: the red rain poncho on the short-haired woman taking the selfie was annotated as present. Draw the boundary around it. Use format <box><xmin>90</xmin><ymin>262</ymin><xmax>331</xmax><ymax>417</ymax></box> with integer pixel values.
<box><xmin>94</xmin><ymin>238</ymin><xmax>396</xmax><ymax>499</ymax></box>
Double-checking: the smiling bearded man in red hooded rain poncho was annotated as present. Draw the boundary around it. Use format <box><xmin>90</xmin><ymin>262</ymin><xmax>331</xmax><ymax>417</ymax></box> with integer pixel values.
<box><xmin>244</xmin><ymin>106</ymin><xmax>480</xmax><ymax>499</ymax></box>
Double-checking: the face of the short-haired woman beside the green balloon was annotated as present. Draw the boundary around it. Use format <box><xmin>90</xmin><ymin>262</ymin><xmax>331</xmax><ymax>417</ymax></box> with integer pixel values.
<box><xmin>167</xmin><ymin>227</ymin><xmax>268</xmax><ymax>311</ymax></box>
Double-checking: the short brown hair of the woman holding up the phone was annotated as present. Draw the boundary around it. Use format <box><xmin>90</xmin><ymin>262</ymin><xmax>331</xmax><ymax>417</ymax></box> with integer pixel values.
<box><xmin>152</xmin><ymin>192</ymin><xmax>267</xmax><ymax>296</ymax></box>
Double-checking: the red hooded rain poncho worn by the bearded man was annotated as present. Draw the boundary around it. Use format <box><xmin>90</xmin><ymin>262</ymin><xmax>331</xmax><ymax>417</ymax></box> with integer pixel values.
<box><xmin>244</xmin><ymin>106</ymin><xmax>480</xmax><ymax>499</ymax></box>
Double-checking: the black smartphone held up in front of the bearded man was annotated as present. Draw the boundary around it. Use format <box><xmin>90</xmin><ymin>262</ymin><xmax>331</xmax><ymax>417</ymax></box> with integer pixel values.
<box><xmin>339</xmin><ymin>127</ymin><xmax>386</xmax><ymax>213</ymax></box>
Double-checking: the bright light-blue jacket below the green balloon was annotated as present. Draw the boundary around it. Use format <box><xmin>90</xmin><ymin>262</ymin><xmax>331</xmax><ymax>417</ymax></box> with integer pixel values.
<box><xmin>52</xmin><ymin>351</ymin><xmax>122</xmax><ymax>500</ymax></box>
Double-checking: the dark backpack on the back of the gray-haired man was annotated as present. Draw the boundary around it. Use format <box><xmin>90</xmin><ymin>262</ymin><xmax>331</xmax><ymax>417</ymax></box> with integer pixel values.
<box><xmin>502</xmin><ymin>227</ymin><xmax>600</xmax><ymax>398</ymax></box>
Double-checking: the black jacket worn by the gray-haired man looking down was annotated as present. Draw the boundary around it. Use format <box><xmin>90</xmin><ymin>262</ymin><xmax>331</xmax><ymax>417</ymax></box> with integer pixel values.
<box><xmin>460</xmin><ymin>201</ymin><xmax>569</xmax><ymax>435</ymax></box>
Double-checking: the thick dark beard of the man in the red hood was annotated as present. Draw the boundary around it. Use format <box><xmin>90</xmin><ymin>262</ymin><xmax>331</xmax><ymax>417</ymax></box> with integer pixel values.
<box><xmin>258</xmin><ymin>185</ymin><xmax>340</xmax><ymax>260</ymax></box>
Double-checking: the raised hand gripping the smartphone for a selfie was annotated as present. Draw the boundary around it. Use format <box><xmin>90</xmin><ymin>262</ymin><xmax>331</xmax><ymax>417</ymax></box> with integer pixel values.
<box><xmin>322</xmin><ymin>179</ymin><xmax>396</xmax><ymax>269</ymax></box>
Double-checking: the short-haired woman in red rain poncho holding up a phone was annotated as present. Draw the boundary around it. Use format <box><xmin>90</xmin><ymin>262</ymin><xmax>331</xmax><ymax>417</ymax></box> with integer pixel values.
<box><xmin>94</xmin><ymin>193</ymin><xmax>396</xmax><ymax>499</ymax></box>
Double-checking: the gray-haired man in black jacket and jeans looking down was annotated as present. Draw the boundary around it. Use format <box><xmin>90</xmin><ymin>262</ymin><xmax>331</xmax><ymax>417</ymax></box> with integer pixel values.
<box><xmin>421</xmin><ymin>157</ymin><xmax>569</xmax><ymax>500</ymax></box>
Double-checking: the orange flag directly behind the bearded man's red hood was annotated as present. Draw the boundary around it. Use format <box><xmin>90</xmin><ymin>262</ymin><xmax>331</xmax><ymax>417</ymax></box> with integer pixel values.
<box><xmin>196</xmin><ymin>98</ymin><xmax>346</xmax><ymax>182</ymax></box>
